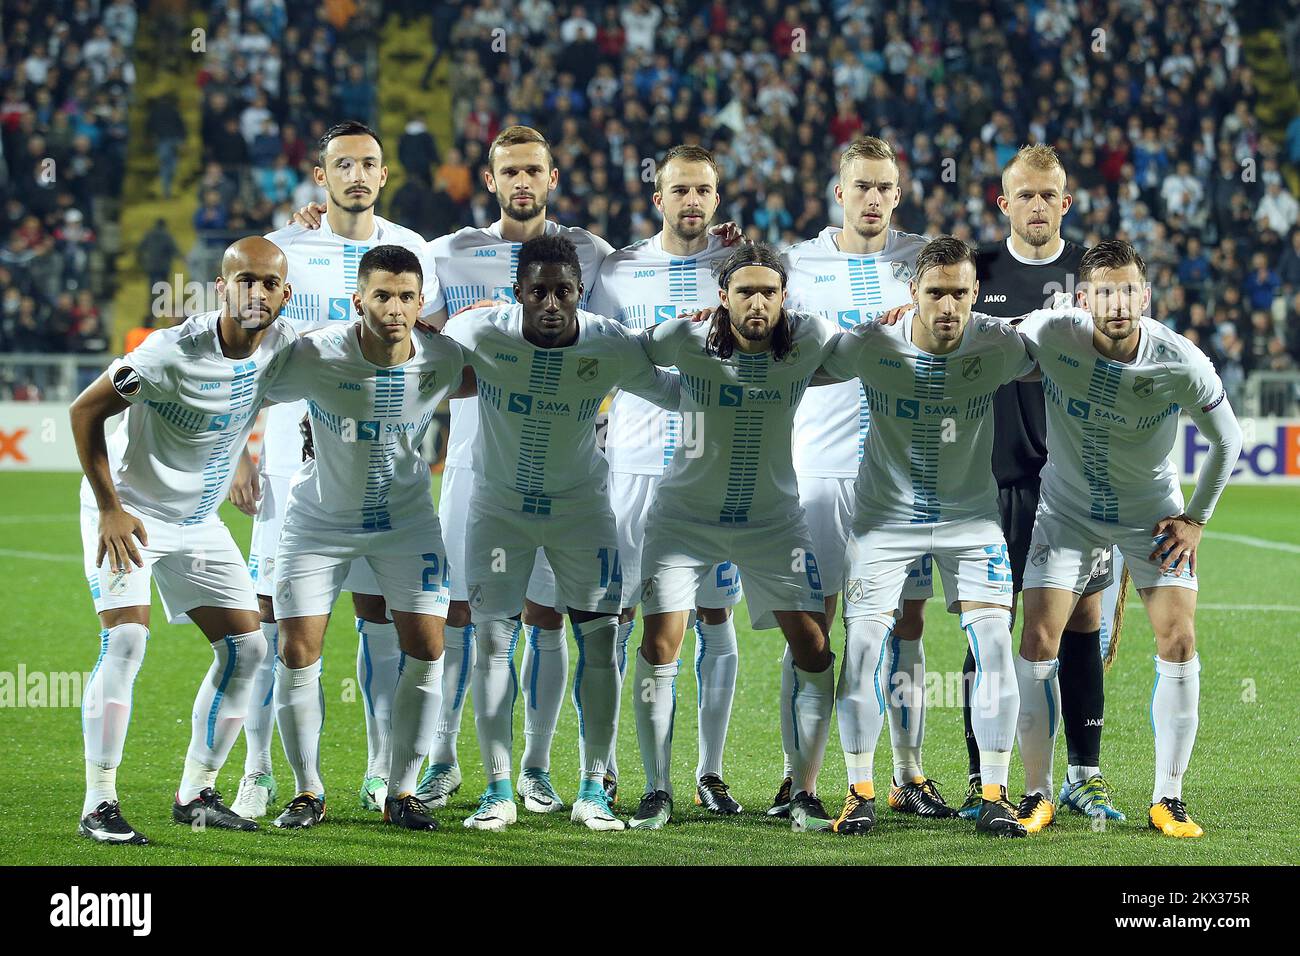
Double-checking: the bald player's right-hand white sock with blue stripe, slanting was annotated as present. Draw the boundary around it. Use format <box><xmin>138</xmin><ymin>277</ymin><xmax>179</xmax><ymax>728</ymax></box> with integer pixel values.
<box><xmin>177</xmin><ymin>630</ymin><xmax>267</xmax><ymax>804</ymax></box>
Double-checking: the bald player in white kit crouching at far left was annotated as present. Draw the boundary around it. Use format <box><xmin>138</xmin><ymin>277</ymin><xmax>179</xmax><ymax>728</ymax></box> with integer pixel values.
<box><xmin>72</xmin><ymin>237</ymin><xmax>296</xmax><ymax>844</ymax></box>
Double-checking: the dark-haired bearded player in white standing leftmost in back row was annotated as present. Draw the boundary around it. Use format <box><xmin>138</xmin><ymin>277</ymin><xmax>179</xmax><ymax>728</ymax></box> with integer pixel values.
<box><xmin>230</xmin><ymin>122</ymin><xmax>446</xmax><ymax>818</ymax></box>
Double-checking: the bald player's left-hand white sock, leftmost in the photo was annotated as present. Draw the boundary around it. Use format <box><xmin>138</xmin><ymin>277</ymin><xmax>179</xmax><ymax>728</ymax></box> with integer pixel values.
<box><xmin>82</xmin><ymin>624</ymin><xmax>150</xmax><ymax>817</ymax></box>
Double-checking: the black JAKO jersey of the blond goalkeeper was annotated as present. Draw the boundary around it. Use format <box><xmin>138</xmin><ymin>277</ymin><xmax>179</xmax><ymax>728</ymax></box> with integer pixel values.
<box><xmin>974</xmin><ymin>241</ymin><xmax>1087</xmax><ymax>488</ymax></box>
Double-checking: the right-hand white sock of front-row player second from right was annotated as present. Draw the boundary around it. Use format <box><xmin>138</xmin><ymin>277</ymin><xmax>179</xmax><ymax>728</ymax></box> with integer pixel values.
<box><xmin>961</xmin><ymin>607</ymin><xmax>1021</xmax><ymax>787</ymax></box>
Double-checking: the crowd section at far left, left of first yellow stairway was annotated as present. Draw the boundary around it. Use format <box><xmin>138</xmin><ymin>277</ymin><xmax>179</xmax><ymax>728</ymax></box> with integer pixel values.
<box><xmin>0</xmin><ymin>0</ymin><xmax>138</xmax><ymax>398</ymax></box>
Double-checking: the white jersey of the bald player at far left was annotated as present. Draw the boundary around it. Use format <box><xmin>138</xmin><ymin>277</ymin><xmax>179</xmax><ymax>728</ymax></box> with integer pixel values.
<box><xmin>82</xmin><ymin>312</ymin><xmax>298</xmax><ymax>524</ymax></box>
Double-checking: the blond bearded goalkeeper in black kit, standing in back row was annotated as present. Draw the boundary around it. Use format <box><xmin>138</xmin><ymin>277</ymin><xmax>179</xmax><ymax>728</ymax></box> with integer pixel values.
<box><xmin>961</xmin><ymin>144</ymin><xmax>1125</xmax><ymax>832</ymax></box>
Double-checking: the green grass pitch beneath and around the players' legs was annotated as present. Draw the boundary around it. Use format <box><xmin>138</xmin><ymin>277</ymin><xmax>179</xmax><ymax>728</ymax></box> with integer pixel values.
<box><xmin>0</xmin><ymin>473</ymin><xmax>1300</xmax><ymax>866</ymax></box>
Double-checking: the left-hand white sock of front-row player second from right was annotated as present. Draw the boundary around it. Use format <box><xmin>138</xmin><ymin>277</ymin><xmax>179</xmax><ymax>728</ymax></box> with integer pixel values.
<box><xmin>832</xmin><ymin>618</ymin><xmax>893</xmax><ymax>791</ymax></box>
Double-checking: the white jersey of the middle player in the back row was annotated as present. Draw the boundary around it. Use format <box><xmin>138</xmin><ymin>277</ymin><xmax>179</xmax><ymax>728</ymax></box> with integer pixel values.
<box><xmin>588</xmin><ymin>233</ymin><xmax>732</xmax><ymax>475</ymax></box>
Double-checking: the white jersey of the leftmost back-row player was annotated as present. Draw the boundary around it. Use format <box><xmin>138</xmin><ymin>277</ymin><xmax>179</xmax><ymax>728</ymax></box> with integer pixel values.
<box><xmin>263</xmin><ymin>216</ymin><xmax>443</xmax><ymax>477</ymax></box>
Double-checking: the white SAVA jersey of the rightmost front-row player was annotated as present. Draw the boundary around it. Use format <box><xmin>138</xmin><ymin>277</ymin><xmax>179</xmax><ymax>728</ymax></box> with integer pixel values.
<box><xmin>1017</xmin><ymin>308</ymin><xmax>1225</xmax><ymax>525</ymax></box>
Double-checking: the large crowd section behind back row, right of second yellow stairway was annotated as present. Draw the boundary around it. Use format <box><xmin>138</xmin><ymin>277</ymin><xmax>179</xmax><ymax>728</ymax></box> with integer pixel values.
<box><xmin>418</xmin><ymin>0</ymin><xmax>1300</xmax><ymax>398</ymax></box>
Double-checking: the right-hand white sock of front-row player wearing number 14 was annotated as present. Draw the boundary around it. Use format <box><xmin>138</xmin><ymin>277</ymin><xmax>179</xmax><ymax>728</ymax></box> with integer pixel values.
<box><xmin>573</xmin><ymin>617</ymin><xmax>621</xmax><ymax>780</ymax></box>
